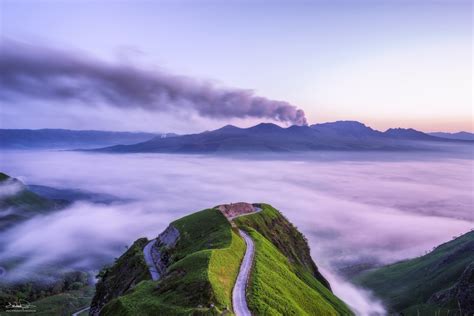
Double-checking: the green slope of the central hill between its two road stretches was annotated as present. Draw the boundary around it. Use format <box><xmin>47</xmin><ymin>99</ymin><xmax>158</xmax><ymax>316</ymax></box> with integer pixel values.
<box><xmin>97</xmin><ymin>209</ymin><xmax>245</xmax><ymax>315</ymax></box>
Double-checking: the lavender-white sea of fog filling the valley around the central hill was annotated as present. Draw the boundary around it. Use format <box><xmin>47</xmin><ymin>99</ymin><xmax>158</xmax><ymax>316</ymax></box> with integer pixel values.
<box><xmin>0</xmin><ymin>151</ymin><xmax>474</xmax><ymax>314</ymax></box>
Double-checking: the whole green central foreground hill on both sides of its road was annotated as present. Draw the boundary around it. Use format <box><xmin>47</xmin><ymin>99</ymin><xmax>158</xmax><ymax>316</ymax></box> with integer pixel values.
<box><xmin>91</xmin><ymin>205</ymin><xmax>352</xmax><ymax>316</ymax></box>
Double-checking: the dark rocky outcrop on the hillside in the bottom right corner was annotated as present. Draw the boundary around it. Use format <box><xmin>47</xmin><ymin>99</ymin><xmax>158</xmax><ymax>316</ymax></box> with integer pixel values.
<box><xmin>429</xmin><ymin>262</ymin><xmax>474</xmax><ymax>315</ymax></box>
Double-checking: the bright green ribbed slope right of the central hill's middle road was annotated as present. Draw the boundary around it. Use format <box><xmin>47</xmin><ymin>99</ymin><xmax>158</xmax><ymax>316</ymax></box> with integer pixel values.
<box><xmin>235</xmin><ymin>204</ymin><xmax>352</xmax><ymax>315</ymax></box>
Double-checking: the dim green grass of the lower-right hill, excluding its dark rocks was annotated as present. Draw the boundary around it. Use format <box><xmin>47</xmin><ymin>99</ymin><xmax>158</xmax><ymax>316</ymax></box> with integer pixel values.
<box><xmin>354</xmin><ymin>231</ymin><xmax>474</xmax><ymax>315</ymax></box>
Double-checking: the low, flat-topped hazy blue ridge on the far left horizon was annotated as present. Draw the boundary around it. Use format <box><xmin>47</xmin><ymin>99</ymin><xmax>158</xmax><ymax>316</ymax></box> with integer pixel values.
<box><xmin>0</xmin><ymin>129</ymin><xmax>165</xmax><ymax>149</ymax></box>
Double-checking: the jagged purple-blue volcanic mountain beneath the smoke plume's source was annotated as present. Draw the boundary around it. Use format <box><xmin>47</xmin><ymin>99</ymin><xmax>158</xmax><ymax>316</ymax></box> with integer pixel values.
<box><xmin>94</xmin><ymin>121</ymin><xmax>474</xmax><ymax>153</ymax></box>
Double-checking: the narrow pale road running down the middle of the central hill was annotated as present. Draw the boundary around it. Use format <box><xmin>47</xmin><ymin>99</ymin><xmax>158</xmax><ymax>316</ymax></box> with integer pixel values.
<box><xmin>232</xmin><ymin>229</ymin><xmax>255</xmax><ymax>316</ymax></box>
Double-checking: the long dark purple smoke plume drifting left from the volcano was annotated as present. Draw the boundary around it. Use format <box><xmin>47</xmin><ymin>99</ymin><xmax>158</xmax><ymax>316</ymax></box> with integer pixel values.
<box><xmin>0</xmin><ymin>40</ymin><xmax>307</xmax><ymax>125</ymax></box>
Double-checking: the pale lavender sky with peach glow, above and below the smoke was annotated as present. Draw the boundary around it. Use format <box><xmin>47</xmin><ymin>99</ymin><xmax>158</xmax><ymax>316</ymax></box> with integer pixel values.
<box><xmin>0</xmin><ymin>0</ymin><xmax>473</xmax><ymax>132</ymax></box>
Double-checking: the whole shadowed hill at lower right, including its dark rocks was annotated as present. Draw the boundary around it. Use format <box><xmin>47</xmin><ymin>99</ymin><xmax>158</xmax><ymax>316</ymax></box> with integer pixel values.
<box><xmin>354</xmin><ymin>231</ymin><xmax>474</xmax><ymax>315</ymax></box>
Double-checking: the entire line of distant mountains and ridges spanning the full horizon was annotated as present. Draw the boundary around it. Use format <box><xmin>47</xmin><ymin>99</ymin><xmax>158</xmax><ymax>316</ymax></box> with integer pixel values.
<box><xmin>0</xmin><ymin>121</ymin><xmax>474</xmax><ymax>153</ymax></box>
